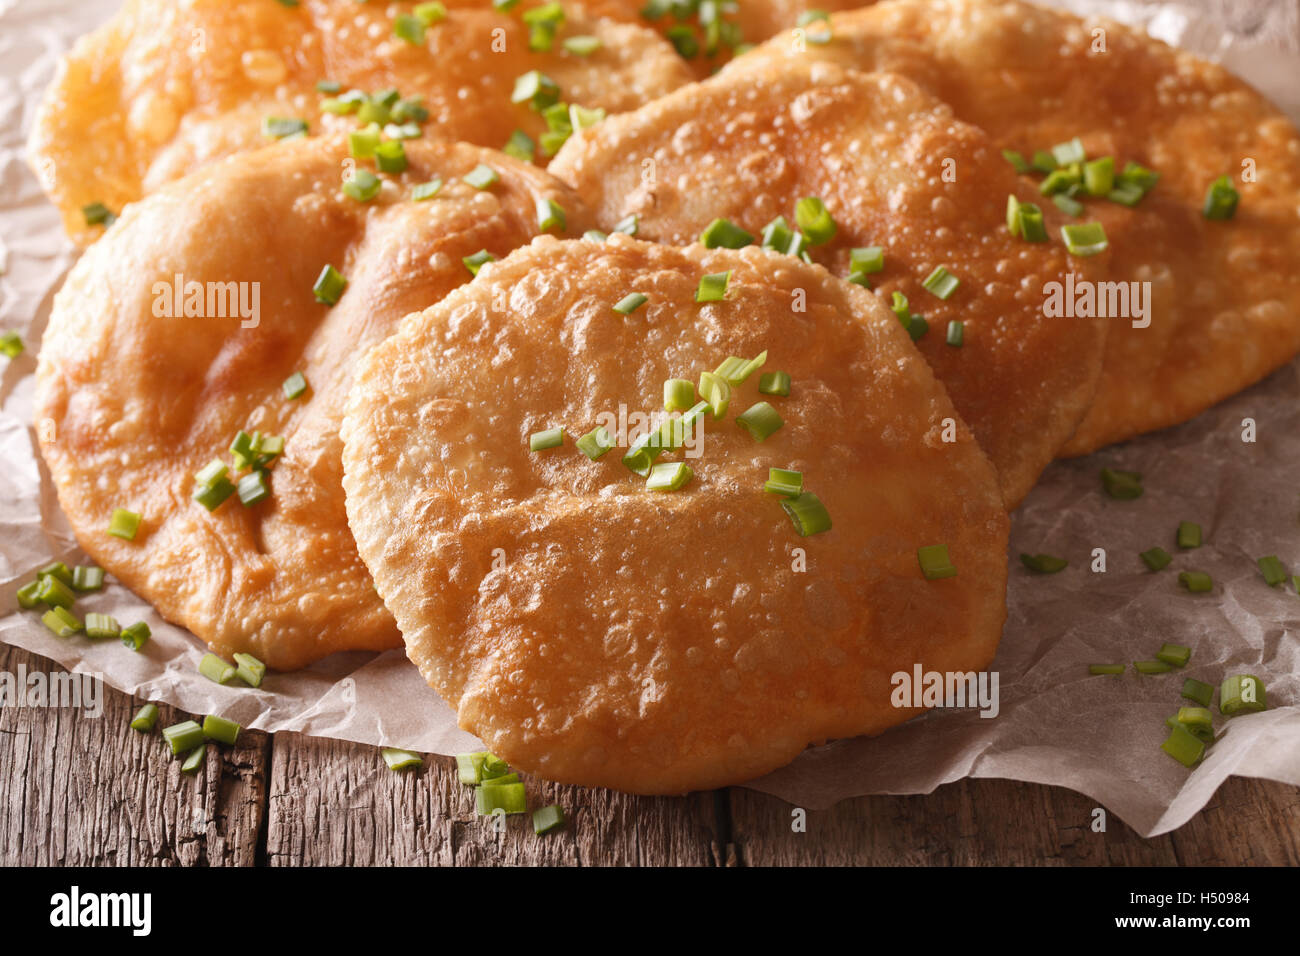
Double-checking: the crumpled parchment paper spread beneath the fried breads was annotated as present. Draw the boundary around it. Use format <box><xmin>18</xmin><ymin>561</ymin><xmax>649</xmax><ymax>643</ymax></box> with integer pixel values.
<box><xmin>0</xmin><ymin>0</ymin><xmax>1300</xmax><ymax>836</ymax></box>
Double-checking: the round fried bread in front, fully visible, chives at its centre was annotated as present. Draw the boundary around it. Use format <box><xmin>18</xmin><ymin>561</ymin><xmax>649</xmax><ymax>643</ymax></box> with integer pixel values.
<box><xmin>342</xmin><ymin>235</ymin><xmax>1008</xmax><ymax>793</ymax></box>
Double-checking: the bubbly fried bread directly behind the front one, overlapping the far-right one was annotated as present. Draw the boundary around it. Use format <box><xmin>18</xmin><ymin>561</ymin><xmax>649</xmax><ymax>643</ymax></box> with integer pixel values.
<box><xmin>550</xmin><ymin>62</ymin><xmax>1108</xmax><ymax>507</ymax></box>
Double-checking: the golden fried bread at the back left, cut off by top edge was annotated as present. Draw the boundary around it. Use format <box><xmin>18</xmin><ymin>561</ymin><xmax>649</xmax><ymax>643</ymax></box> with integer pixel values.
<box><xmin>30</xmin><ymin>0</ymin><xmax>692</xmax><ymax>245</ymax></box>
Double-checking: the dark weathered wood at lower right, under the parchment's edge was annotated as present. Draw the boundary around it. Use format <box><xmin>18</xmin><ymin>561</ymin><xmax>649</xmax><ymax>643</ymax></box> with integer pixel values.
<box><xmin>731</xmin><ymin>778</ymin><xmax>1300</xmax><ymax>866</ymax></box>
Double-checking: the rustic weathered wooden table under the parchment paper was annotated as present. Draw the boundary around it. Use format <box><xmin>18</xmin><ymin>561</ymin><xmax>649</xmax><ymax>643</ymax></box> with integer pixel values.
<box><xmin>0</xmin><ymin>0</ymin><xmax>1300</xmax><ymax>866</ymax></box>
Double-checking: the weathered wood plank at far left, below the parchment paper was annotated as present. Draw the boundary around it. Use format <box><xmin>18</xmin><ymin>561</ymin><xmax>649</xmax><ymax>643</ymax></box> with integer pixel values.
<box><xmin>0</xmin><ymin>645</ymin><xmax>269</xmax><ymax>866</ymax></box>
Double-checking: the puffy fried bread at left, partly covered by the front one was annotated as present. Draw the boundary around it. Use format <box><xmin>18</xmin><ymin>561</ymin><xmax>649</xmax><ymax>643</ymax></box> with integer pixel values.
<box><xmin>35</xmin><ymin>138</ymin><xmax>595</xmax><ymax>669</ymax></box>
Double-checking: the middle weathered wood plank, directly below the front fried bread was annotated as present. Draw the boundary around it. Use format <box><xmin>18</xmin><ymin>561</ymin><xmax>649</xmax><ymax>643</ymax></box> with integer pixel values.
<box><xmin>267</xmin><ymin>734</ymin><xmax>724</xmax><ymax>866</ymax></box>
